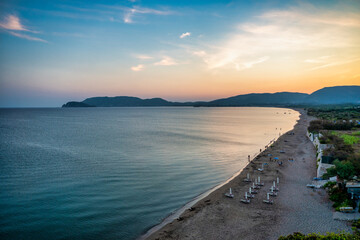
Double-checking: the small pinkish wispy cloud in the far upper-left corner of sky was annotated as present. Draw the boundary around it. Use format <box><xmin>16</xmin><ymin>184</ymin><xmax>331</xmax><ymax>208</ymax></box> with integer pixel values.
<box><xmin>0</xmin><ymin>14</ymin><xmax>47</xmax><ymax>42</ymax></box>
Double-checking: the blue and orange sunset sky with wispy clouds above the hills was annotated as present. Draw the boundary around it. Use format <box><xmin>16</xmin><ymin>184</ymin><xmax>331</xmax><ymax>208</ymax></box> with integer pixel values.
<box><xmin>0</xmin><ymin>0</ymin><xmax>360</xmax><ymax>107</ymax></box>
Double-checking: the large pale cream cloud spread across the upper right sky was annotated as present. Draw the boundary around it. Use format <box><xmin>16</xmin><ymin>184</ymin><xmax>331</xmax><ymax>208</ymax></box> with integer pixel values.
<box><xmin>192</xmin><ymin>4</ymin><xmax>360</xmax><ymax>70</ymax></box>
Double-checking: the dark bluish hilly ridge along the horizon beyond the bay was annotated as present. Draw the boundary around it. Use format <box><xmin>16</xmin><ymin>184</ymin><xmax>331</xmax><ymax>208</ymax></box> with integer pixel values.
<box><xmin>62</xmin><ymin>86</ymin><xmax>360</xmax><ymax>108</ymax></box>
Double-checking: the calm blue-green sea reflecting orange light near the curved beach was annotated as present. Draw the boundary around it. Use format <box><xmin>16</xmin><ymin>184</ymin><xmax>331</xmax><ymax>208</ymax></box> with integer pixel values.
<box><xmin>0</xmin><ymin>108</ymin><xmax>298</xmax><ymax>240</ymax></box>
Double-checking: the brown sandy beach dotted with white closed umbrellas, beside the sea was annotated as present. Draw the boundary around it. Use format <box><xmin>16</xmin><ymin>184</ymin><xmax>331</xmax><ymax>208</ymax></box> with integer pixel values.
<box><xmin>147</xmin><ymin>110</ymin><xmax>350</xmax><ymax>240</ymax></box>
